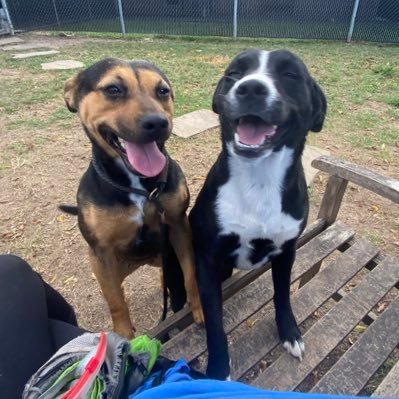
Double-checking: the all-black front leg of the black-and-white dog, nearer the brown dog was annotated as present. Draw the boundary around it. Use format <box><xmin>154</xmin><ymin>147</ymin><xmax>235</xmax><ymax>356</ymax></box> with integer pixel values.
<box><xmin>196</xmin><ymin>257</ymin><xmax>230</xmax><ymax>380</ymax></box>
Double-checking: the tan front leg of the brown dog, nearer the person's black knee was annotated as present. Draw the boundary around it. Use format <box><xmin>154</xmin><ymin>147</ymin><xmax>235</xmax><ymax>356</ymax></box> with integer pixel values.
<box><xmin>89</xmin><ymin>250</ymin><xmax>135</xmax><ymax>339</ymax></box>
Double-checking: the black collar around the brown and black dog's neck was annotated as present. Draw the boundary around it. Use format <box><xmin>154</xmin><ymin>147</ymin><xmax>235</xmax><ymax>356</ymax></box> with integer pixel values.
<box><xmin>91</xmin><ymin>152</ymin><xmax>169</xmax><ymax>213</ymax></box>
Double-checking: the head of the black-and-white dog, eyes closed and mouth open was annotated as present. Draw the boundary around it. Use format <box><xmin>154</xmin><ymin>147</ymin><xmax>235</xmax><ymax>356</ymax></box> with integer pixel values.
<box><xmin>212</xmin><ymin>50</ymin><xmax>327</xmax><ymax>157</ymax></box>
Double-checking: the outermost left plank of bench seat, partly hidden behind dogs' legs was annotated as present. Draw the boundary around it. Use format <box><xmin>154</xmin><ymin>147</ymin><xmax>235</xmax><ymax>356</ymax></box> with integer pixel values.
<box><xmin>147</xmin><ymin>219</ymin><xmax>326</xmax><ymax>339</ymax></box>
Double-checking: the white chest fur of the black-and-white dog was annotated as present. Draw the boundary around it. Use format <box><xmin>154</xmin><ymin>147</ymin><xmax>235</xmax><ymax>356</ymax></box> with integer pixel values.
<box><xmin>216</xmin><ymin>147</ymin><xmax>302</xmax><ymax>270</ymax></box>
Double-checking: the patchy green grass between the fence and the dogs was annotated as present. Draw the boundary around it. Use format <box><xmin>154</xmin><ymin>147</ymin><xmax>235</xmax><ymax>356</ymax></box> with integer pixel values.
<box><xmin>0</xmin><ymin>34</ymin><xmax>399</xmax><ymax>159</ymax></box>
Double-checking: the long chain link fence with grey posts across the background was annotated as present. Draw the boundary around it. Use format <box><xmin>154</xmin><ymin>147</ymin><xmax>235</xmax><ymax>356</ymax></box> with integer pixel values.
<box><xmin>3</xmin><ymin>0</ymin><xmax>399</xmax><ymax>43</ymax></box>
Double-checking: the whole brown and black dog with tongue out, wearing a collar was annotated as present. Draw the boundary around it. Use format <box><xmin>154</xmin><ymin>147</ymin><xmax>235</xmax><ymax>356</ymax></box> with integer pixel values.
<box><xmin>60</xmin><ymin>58</ymin><xmax>203</xmax><ymax>338</ymax></box>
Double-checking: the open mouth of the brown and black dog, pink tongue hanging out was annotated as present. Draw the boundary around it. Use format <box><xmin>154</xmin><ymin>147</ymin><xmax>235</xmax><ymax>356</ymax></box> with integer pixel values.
<box><xmin>105</xmin><ymin>131</ymin><xmax>166</xmax><ymax>177</ymax></box>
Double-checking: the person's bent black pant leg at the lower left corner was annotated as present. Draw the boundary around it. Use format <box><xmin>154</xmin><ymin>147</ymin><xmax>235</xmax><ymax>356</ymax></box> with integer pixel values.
<box><xmin>0</xmin><ymin>255</ymin><xmax>81</xmax><ymax>398</ymax></box>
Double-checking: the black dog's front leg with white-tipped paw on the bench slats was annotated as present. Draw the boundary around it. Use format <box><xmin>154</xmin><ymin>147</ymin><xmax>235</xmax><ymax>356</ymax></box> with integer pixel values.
<box><xmin>272</xmin><ymin>242</ymin><xmax>305</xmax><ymax>360</ymax></box>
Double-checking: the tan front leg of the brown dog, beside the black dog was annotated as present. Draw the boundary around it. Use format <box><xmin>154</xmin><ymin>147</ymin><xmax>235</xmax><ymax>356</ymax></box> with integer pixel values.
<box><xmin>169</xmin><ymin>215</ymin><xmax>204</xmax><ymax>324</ymax></box>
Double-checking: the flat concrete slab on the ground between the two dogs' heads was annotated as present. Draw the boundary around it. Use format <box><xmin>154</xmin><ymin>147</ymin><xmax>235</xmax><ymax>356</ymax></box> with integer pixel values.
<box><xmin>173</xmin><ymin>109</ymin><xmax>219</xmax><ymax>138</ymax></box>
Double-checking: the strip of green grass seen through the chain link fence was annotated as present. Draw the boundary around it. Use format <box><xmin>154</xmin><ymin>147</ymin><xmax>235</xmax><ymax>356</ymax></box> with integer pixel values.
<box><xmin>45</xmin><ymin>16</ymin><xmax>399</xmax><ymax>43</ymax></box>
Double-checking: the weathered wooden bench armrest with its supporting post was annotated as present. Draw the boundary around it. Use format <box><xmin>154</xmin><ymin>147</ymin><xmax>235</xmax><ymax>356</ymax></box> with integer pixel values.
<box><xmin>312</xmin><ymin>155</ymin><xmax>399</xmax><ymax>225</ymax></box>
